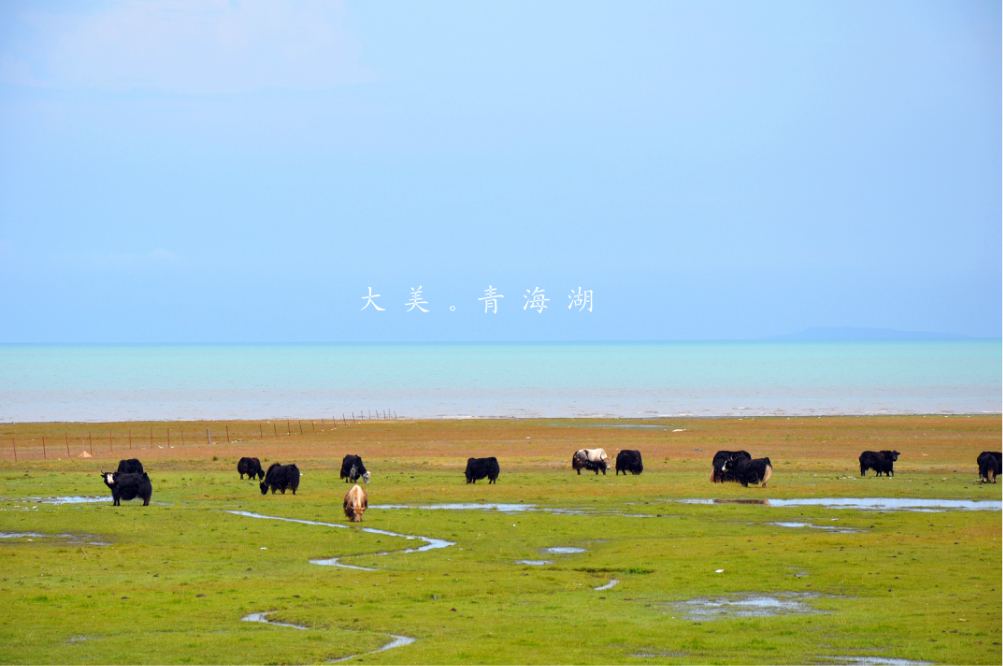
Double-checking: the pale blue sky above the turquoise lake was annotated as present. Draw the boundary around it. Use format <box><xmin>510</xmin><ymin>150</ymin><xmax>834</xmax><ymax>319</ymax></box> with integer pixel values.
<box><xmin>0</xmin><ymin>0</ymin><xmax>1003</xmax><ymax>343</ymax></box>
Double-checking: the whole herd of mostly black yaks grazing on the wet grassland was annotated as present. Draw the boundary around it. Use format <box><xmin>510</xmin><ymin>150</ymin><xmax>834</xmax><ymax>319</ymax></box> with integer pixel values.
<box><xmin>101</xmin><ymin>448</ymin><xmax>1003</xmax><ymax>523</ymax></box>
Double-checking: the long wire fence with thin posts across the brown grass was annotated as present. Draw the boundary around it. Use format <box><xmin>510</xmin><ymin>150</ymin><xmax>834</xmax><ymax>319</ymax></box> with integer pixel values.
<box><xmin>0</xmin><ymin>409</ymin><xmax>399</xmax><ymax>462</ymax></box>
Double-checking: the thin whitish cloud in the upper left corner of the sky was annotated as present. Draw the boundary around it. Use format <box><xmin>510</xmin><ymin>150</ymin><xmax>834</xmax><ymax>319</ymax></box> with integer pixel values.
<box><xmin>0</xmin><ymin>0</ymin><xmax>375</xmax><ymax>94</ymax></box>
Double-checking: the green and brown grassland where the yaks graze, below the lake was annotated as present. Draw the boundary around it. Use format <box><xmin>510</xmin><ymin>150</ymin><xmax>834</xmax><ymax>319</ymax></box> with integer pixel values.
<box><xmin>0</xmin><ymin>416</ymin><xmax>1003</xmax><ymax>664</ymax></box>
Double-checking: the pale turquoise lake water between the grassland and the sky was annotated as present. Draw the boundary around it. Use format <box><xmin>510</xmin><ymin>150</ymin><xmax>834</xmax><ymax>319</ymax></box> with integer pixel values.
<box><xmin>0</xmin><ymin>340</ymin><xmax>1003</xmax><ymax>422</ymax></box>
